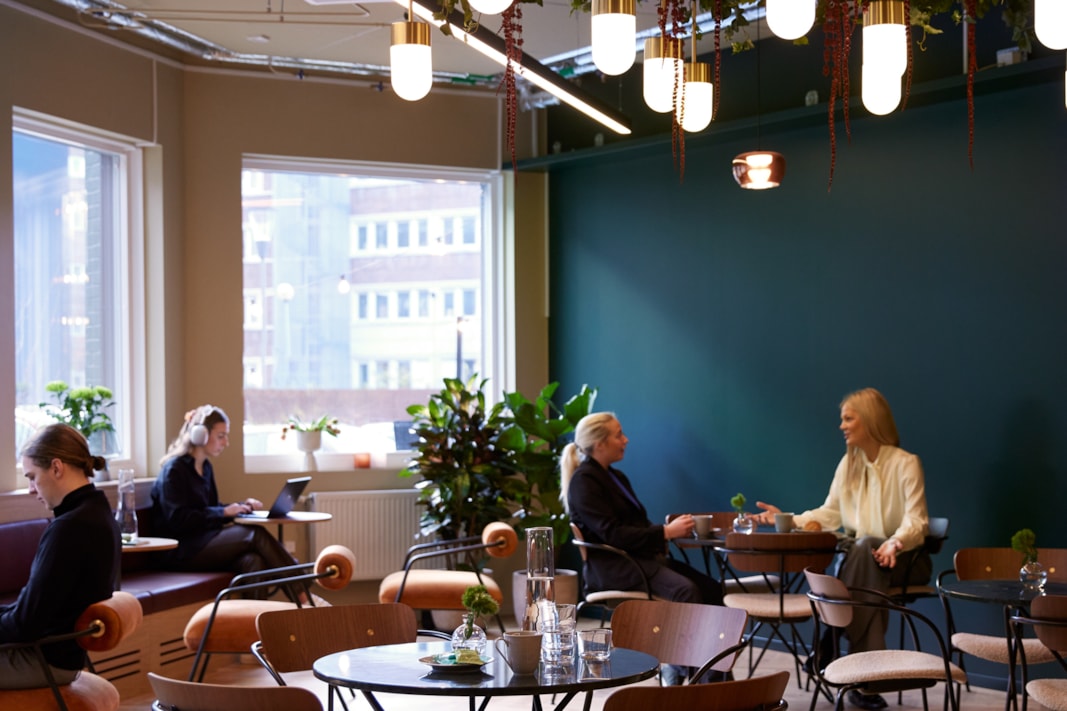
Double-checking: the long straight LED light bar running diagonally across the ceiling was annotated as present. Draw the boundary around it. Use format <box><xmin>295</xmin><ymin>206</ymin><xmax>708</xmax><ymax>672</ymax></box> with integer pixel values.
<box><xmin>396</xmin><ymin>0</ymin><xmax>631</xmax><ymax>136</ymax></box>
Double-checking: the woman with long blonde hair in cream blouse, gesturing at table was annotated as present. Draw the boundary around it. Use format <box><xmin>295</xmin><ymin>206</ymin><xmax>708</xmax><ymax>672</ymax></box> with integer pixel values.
<box><xmin>757</xmin><ymin>388</ymin><xmax>931</xmax><ymax>709</ymax></box>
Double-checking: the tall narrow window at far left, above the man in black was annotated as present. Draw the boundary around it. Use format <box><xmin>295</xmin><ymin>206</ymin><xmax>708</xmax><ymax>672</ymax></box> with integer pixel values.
<box><xmin>11</xmin><ymin>113</ymin><xmax>141</xmax><ymax>469</ymax></box>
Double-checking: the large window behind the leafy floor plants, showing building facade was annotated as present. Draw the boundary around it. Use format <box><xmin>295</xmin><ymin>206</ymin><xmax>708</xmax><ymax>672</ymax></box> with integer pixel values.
<box><xmin>242</xmin><ymin>157</ymin><xmax>507</xmax><ymax>463</ymax></box>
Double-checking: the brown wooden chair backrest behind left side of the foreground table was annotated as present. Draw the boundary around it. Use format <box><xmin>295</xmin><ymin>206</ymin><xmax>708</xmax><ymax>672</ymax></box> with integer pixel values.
<box><xmin>252</xmin><ymin>602</ymin><xmax>451</xmax><ymax>708</ymax></box>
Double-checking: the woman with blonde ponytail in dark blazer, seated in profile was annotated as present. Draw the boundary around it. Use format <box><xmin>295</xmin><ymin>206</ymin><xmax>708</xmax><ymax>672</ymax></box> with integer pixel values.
<box><xmin>560</xmin><ymin>412</ymin><xmax>722</xmax><ymax>604</ymax></box>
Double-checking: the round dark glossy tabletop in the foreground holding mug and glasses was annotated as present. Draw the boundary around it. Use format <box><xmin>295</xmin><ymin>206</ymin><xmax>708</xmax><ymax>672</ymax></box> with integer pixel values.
<box><xmin>312</xmin><ymin>642</ymin><xmax>659</xmax><ymax>711</ymax></box>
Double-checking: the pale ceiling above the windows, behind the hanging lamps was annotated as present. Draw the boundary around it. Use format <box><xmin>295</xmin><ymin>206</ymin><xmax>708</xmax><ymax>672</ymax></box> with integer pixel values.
<box><xmin>19</xmin><ymin>0</ymin><xmax>734</xmax><ymax>89</ymax></box>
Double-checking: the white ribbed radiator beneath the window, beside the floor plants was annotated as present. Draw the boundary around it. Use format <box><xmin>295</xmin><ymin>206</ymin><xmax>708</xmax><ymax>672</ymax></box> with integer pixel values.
<box><xmin>308</xmin><ymin>489</ymin><xmax>423</xmax><ymax>580</ymax></box>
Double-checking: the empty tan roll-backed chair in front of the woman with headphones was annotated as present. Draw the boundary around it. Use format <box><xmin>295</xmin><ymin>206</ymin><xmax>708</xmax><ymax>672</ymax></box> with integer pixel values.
<box><xmin>182</xmin><ymin>546</ymin><xmax>355</xmax><ymax>681</ymax></box>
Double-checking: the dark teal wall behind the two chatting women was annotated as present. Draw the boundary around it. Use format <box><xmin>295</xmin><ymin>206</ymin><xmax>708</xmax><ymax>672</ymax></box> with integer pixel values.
<box><xmin>550</xmin><ymin>74</ymin><xmax>1067</xmax><ymax>678</ymax></box>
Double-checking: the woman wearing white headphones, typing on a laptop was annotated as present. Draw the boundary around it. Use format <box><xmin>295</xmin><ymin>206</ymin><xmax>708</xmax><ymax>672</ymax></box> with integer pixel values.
<box><xmin>152</xmin><ymin>405</ymin><xmax>306</xmax><ymax>602</ymax></box>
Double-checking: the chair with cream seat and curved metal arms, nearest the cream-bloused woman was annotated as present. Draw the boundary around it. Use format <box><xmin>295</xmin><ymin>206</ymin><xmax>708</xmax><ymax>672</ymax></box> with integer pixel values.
<box><xmin>805</xmin><ymin>568</ymin><xmax>967</xmax><ymax>711</ymax></box>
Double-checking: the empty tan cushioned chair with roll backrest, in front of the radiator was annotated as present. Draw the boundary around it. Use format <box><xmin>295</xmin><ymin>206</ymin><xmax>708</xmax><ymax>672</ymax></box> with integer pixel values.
<box><xmin>378</xmin><ymin>521</ymin><xmax>519</xmax><ymax>632</ymax></box>
